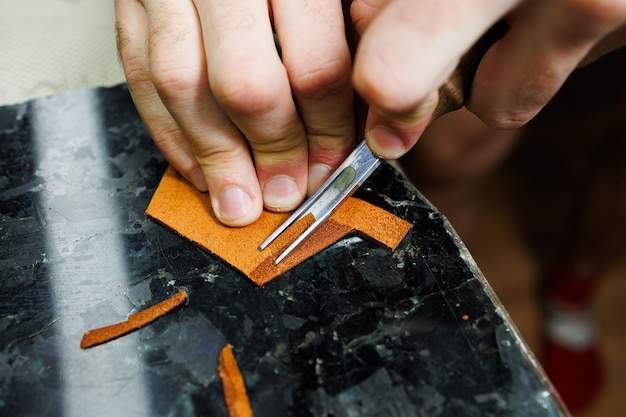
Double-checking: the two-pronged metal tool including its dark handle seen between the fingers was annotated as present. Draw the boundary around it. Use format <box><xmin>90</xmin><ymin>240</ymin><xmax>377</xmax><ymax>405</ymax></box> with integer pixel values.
<box><xmin>259</xmin><ymin>22</ymin><xmax>508</xmax><ymax>265</ymax></box>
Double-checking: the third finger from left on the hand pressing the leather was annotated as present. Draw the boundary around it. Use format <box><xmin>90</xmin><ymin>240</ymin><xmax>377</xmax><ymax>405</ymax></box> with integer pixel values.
<box><xmin>196</xmin><ymin>0</ymin><xmax>307</xmax><ymax>211</ymax></box>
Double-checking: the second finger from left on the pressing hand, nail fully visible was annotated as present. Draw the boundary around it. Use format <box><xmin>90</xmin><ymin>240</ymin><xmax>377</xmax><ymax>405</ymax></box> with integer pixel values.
<box><xmin>145</xmin><ymin>0</ymin><xmax>262</xmax><ymax>226</ymax></box>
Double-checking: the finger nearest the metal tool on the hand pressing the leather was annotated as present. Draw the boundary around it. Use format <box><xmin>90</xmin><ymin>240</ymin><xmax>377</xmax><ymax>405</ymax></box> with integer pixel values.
<box><xmin>272</xmin><ymin>0</ymin><xmax>355</xmax><ymax>194</ymax></box>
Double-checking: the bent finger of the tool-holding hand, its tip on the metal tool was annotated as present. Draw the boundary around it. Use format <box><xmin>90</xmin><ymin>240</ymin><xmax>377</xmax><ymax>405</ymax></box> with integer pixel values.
<box><xmin>353</xmin><ymin>0</ymin><xmax>519</xmax><ymax>158</ymax></box>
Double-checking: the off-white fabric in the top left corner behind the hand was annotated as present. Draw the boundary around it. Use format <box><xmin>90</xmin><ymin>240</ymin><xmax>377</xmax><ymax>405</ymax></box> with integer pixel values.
<box><xmin>0</xmin><ymin>0</ymin><xmax>124</xmax><ymax>105</ymax></box>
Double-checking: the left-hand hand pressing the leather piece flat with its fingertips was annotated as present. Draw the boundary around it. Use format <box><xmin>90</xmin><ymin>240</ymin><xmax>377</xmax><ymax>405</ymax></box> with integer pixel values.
<box><xmin>115</xmin><ymin>0</ymin><xmax>354</xmax><ymax>226</ymax></box>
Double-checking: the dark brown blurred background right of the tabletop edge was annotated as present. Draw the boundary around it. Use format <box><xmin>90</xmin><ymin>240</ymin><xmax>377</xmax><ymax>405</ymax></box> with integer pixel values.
<box><xmin>402</xmin><ymin>47</ymin><xmax>626</xmax><ymax>417</ymax></box>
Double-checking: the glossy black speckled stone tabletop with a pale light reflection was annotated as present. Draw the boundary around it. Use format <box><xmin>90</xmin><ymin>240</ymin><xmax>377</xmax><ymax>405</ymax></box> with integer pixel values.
<box><xmin>0</xmin><ymin>86</ymin><xmax>566</xmax><ymax>417</ymax></box>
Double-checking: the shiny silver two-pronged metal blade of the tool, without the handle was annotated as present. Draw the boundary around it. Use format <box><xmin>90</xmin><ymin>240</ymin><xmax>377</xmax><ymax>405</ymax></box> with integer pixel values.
<box><xmin>259</xmin><ymin>141</ymin><xmax>381</xmax><ymax>265</ymax></box>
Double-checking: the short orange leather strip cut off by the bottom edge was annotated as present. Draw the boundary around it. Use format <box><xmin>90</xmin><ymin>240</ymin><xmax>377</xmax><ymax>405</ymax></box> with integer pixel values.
<box><xmin>217</xmin><ymin>345</ymin><xmax>252</xmax><ymax>417</ymax></box>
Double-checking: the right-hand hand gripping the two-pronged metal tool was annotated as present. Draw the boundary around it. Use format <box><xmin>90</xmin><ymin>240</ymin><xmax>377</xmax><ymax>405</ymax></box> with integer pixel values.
<box><xmin>351</xmin><ymin>0</ymin><xmax>626</xmax><ymax>159</ymax></box>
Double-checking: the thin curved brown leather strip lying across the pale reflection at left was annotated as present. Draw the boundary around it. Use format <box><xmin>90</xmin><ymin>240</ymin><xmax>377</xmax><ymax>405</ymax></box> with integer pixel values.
<box><xmin>80</xmin><ymin>290</ymin><xmax>187</xmax><ymax>349</ymax></box>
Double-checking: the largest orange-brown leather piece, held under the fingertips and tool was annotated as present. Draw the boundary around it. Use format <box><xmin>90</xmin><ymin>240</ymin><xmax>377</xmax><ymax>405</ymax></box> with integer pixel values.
<box><xmin>146</xmin><ymin>167</ymin><xmax>412</xmax><ymax>285</ymax></box>
